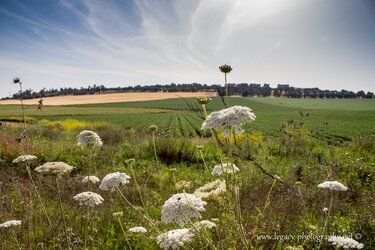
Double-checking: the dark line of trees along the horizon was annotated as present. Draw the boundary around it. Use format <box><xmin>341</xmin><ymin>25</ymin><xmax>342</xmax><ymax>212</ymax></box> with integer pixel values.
<box><xmin>3</xmin><ymin>83</ymin><xmax>374</xmax><ymax>99</ymax></box>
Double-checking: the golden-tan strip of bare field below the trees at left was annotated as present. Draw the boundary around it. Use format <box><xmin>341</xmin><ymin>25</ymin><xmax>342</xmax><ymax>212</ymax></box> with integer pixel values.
<box><xmin>0</xmin><ymin>92</ymin><xmax>216</xmax><ymax>106</ymax></box>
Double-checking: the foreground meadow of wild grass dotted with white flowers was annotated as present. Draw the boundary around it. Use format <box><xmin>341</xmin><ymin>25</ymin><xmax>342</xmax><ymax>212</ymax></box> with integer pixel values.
<box><xmin>0</xmin><ymin>94</ymin><xmax>375</xmax><ymax>250</ymax></box>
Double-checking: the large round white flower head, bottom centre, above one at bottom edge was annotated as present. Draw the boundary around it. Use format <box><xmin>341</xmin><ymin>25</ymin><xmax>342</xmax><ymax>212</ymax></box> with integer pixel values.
<box><xmin>161</xmin><ymin>193</ymin><xmax>207</xmax><ymax>226</ymax></box>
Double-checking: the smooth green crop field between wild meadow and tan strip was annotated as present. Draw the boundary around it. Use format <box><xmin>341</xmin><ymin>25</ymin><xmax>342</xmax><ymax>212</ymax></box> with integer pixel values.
<box><xmin>0</xmin><ymin>97</ymin><xmax>375</xmax><ymax>139</ymax></box>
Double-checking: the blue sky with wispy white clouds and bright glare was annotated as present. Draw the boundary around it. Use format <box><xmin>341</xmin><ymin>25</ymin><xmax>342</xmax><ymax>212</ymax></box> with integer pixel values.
<box><xmin>0</xmin><ymin>0</ymin><xmax>375</xmax><ymax>97</ymax></box>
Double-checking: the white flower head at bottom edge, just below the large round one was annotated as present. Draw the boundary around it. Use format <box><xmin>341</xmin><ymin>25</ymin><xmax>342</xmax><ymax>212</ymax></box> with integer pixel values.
<box><xmin>156</xmin><ymin>228</ymin><xmax>195</xmax><ymax>249</ymax></box>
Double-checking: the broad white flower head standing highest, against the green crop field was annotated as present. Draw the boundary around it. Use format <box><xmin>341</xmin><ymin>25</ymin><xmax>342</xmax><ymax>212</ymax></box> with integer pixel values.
<box><xmin>202</xmin><ymin>106</ymin><xmax>256</xmax><ymax>132</ymax></box>
